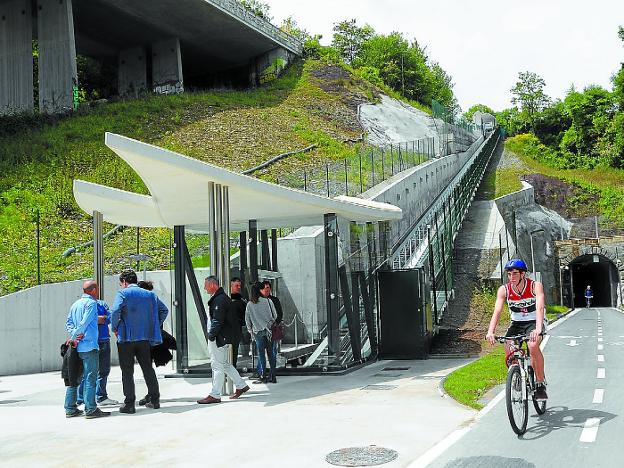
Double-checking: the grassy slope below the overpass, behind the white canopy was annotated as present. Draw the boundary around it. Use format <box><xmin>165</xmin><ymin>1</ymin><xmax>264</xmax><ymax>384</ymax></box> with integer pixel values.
<box><xmin>0</xmin><ymin>62</ymin><xmax>372</xmax><ymax>295</ymax></box>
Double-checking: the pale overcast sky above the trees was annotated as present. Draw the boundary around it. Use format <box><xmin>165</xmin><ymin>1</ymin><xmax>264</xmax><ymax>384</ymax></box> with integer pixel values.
<box><xmin>261</xmin><ymin>0</ymin><xmax>624</xmax><ymax>111</ymax></box>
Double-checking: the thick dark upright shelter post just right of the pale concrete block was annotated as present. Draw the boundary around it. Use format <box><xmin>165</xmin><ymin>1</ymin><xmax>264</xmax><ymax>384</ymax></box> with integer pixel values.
<box><xmin>324</xmin><ymin>213</ymin><xmax>340</xmax><ymax>362</ymax></box>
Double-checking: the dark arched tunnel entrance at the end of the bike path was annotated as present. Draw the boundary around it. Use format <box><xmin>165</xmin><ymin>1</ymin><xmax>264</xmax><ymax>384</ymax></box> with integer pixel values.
<box><xmin>569</xmin><ymin>254</ymin><xmax>620</xmax><ymax>307</ymax></box>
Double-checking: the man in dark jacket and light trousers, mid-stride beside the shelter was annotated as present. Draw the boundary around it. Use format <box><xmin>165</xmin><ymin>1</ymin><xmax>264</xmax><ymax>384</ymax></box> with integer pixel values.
<box><xmin>197</xmin><ymin>276</ymin><xmax>249</xmax><ymax>405</ymax></box>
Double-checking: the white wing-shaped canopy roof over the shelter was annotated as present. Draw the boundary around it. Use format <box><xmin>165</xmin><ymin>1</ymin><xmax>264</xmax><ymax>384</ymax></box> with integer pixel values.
<box><xmin>74</xmin><ymin>133</ymin><xmax>402</xmax><ymax>230</ymax></box>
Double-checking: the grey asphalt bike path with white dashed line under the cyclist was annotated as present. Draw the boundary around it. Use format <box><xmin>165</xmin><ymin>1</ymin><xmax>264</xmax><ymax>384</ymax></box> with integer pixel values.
<box><xmin>420</xmin><ymin>308</ymin><xmax>624</xmax><ymax>468</ymax></box>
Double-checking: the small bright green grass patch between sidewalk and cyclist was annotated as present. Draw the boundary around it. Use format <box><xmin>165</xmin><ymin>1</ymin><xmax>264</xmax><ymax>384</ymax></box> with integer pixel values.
<box><xmin>444</xmin><ymin>345</ymin><xmax>507</xmax><ymax>409</ymax></box>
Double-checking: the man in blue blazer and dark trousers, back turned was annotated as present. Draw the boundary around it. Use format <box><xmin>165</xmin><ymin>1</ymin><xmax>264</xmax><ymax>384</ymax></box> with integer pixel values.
<box><xmin>111</xmin><ymin>270</ymin><xmax>169</xmax><ymax>414</ymax></box>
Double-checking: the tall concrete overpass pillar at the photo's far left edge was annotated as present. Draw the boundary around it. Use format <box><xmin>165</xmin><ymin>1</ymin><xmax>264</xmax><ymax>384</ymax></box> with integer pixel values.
<box><xmin>0</xmin><ymin>0</ymin><xmax>34</xmax><ymax>115</ymax></box>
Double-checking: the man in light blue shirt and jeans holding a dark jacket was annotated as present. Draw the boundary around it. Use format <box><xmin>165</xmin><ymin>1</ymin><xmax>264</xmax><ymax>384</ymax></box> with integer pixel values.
<box><xmin>65</xmin><ymin>280</ymin><xmax>110</xmax><ymax>419</ymax></box>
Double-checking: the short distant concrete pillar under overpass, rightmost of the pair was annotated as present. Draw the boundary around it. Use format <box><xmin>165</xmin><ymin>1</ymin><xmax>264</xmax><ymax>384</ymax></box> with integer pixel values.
<box><xmin>152</xmin><ymin>37</ymin><xmax>184</xmax><ymax>94</ymax></box>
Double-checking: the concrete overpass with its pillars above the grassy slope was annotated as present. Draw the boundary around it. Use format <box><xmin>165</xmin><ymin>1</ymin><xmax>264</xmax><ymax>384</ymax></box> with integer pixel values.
<box><xmin>0</xmin><ymin>0</ymin><xmax>302</xmax><ymax>115</ymax></box>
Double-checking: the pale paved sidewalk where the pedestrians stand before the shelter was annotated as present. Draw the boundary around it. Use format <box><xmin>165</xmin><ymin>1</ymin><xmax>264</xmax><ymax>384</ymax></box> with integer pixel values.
<box><xmin>0</xmin><ymin>359</ymin><xmax>476</xmax><ymax>468</ymax></box>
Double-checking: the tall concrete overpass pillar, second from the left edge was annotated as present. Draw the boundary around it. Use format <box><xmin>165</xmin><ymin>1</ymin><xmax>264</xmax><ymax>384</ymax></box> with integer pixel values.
<box><xmin>37</xmin><ymin>0</ymin><xmax>78</xmax><ymax>114</ymax></box>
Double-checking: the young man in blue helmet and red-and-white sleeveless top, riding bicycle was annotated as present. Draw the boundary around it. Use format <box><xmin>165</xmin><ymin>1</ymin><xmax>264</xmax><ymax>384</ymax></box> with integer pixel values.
<box><xmin>485</xmin><ymin>259</ymin><xmax>548</xmax><ymax>401</ymax></box>
